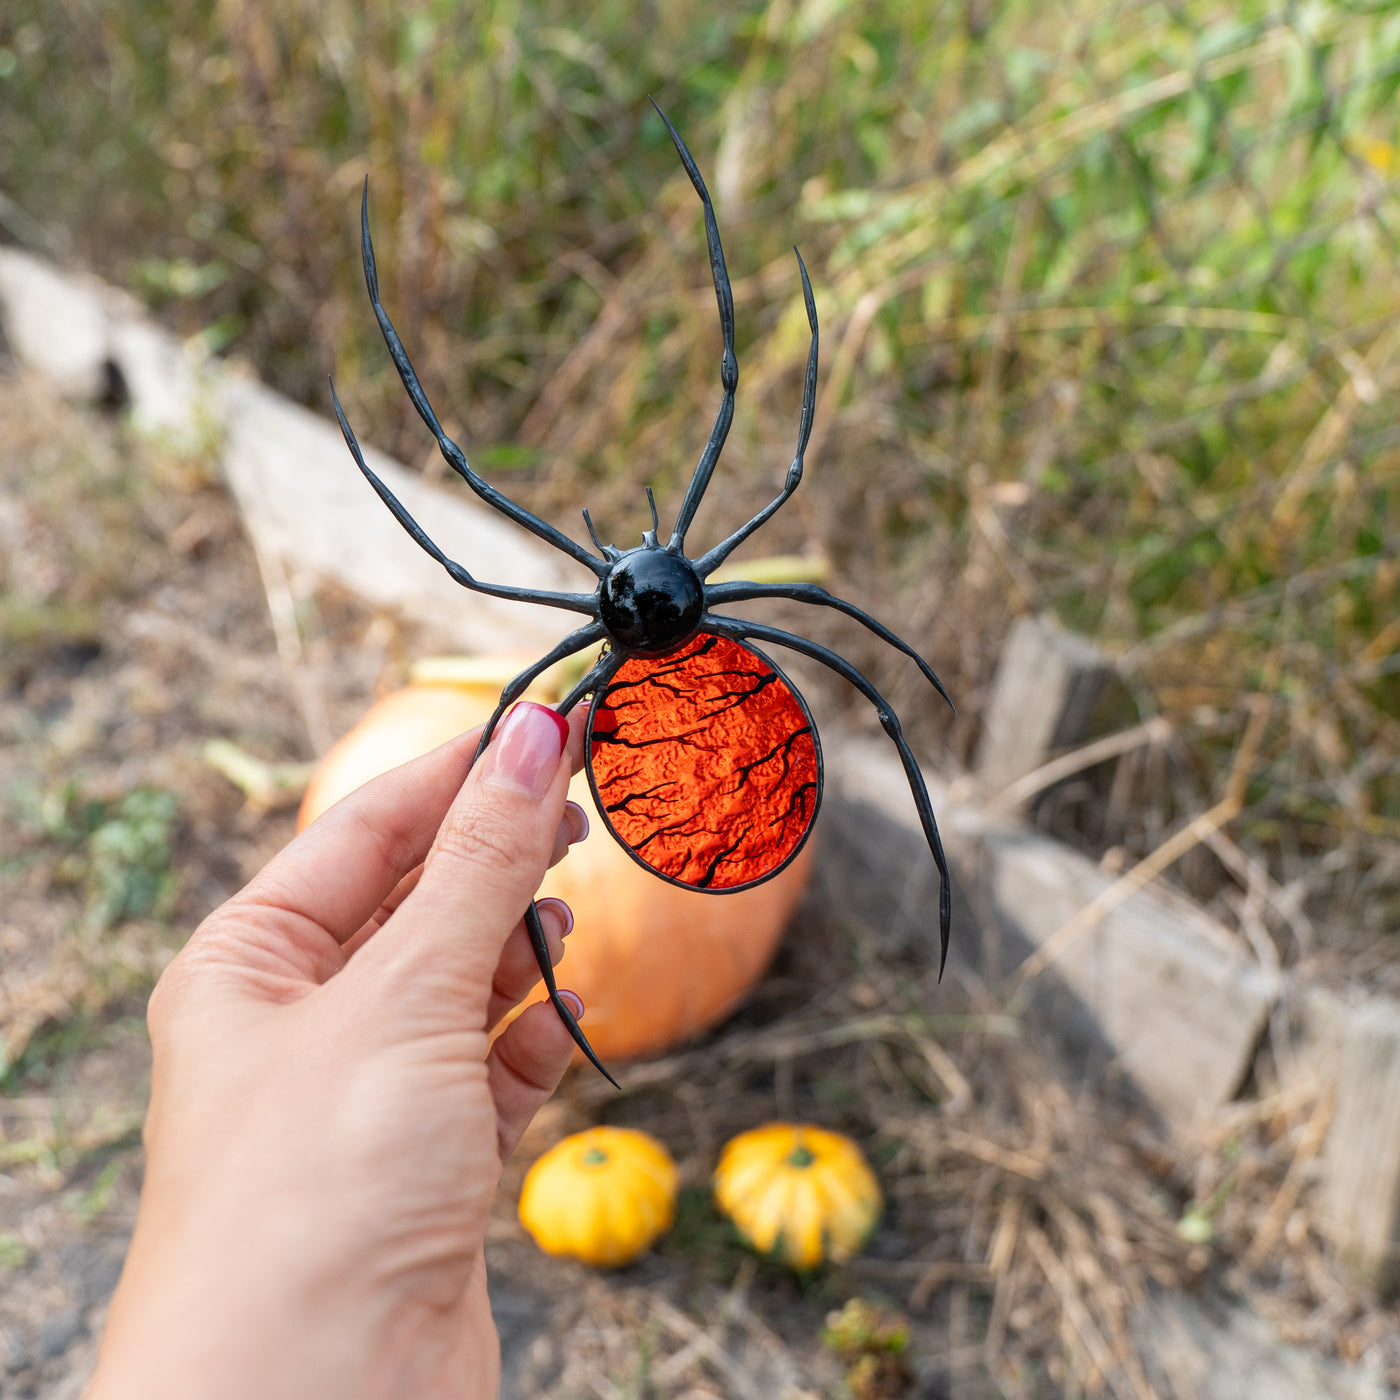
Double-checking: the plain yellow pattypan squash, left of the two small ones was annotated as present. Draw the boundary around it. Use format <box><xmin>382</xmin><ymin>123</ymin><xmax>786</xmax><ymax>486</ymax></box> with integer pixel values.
<box><xmin>519</xmin><ymin>1127</ymin><xmax>676</xmax><ymax>1268</ymax></box>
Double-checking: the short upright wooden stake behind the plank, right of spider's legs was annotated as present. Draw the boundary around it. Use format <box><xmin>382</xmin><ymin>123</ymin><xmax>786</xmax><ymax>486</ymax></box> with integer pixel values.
<box><xmin>976</xmin><ymin>617</ymin><xmax>1112</xmax><ymax>794</ymax></box>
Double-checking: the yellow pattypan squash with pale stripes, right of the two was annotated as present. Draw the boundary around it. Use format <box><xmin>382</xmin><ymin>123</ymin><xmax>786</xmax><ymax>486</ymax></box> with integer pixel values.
<box><xmin>714</xmin><ymin>1123</ymin><xmax>882</xmax><ymax>1268</ymax></box>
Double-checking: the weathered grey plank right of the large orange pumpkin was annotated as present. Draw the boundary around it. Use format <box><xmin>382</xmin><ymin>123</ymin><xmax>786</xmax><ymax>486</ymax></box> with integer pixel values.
<box><xmin>827</xmin><ymin>741</ymin><xmax>1271</xmax><ymax>1128</ymax></box>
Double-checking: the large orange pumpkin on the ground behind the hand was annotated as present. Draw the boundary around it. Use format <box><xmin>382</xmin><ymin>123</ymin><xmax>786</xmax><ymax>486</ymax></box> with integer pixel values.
<box><xmin>297</xmin><ymin>680</ymin><xmax>812</xmax><ymax>1063</ymax></box>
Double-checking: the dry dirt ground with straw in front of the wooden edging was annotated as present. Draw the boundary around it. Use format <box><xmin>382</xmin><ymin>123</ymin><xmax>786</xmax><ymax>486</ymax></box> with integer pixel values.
<box><xmin>0</xmin><ymin>365</ymin><xmax>1400</xmax><ymax>1400</ymax></box>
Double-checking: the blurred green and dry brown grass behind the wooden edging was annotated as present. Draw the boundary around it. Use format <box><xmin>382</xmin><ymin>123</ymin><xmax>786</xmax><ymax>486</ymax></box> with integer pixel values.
<box><xmin>0</xmin><ymin>0</ymin><xmax>1400</xmax><ymax>957</ymax></box>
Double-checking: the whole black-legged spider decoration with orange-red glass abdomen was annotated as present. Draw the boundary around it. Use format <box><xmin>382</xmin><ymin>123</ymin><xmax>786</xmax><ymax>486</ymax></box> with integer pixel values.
<box><xmin>330</xmin><ymin>102</ymin><xmax>952</xmax><ymax>1086</ymax></box>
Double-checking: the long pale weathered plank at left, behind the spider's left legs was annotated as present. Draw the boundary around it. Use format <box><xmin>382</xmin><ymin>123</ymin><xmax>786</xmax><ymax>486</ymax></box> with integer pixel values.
<box><xmin>0</xmin><ymin>249</ymin><xmax>595</xmax><ymax>651</ymax></box>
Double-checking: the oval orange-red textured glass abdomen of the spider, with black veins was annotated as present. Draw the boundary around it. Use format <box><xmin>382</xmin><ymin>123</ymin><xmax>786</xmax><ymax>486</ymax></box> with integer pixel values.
<box><xmin>588</xmin><ymin>633</ymin><xmax>820</xmax><ymax>890</ymax></box>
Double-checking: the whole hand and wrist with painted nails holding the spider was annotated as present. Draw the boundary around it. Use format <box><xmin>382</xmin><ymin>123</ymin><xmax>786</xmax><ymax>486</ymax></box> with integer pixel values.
<box><xmin>87</xmin><ymin>704</ymin><xmax>587</xmax><ymax>1400</ymax></box>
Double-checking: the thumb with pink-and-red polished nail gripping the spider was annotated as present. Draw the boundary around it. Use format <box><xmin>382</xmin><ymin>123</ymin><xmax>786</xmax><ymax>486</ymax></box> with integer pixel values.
<box><xmin>366</xmin><ymin>701</ymin><xmax>570</xmax><ymax>1029</ymax></box>
